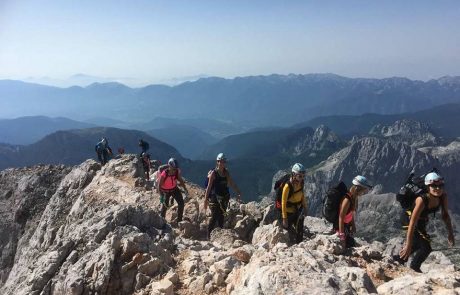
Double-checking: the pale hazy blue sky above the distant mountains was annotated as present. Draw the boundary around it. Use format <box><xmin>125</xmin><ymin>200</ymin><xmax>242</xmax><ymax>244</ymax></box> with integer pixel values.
<box><xmin>0</xmin><ymin>0</ymin><xmax>460</xmax><ymax>86</ymax></box>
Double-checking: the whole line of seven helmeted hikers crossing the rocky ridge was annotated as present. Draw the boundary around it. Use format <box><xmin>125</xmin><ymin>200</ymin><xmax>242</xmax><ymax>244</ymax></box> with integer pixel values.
<box><xmin>96</xmin><ymin>138</ymin><xmax>455</xmax><ymax>272</ymax></box>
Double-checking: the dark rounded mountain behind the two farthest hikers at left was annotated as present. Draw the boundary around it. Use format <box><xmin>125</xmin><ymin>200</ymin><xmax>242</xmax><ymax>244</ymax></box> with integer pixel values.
<box><xmin>0</xmin><ymin>128</ymin><xmax>186</xmax><ymax>169</ymax></box>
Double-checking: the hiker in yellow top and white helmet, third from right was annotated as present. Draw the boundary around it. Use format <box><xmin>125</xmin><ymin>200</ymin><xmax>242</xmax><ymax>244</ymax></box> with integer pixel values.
<box><xmin>281</xmin><ymin>163</ymin><xmax>307</xmax><ymax>244</ymax></box>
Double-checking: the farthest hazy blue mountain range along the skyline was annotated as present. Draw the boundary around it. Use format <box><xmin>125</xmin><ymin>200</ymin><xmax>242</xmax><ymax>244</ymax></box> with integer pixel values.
<box><xmin>0</xmin><ymin>74</ymin><xmax>460</xmax><ymax>128</ymax></box>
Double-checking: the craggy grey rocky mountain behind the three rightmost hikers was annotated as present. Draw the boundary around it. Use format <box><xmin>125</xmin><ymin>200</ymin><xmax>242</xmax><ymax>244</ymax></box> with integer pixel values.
<box><xmin>306</xmin><ymin>137</ymin><xmax>460</xmax><ymax>214</ymax></box>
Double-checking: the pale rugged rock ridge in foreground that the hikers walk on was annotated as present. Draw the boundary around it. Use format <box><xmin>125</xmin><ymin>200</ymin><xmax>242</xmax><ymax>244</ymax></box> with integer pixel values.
<box><xmin>0</xmin><ymin>155</ymin><xmax>460</xmax><ymax>295</ymax></box>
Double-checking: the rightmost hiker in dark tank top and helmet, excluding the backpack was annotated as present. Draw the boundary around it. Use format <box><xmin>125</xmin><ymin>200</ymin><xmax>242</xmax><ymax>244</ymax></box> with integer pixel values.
<box><xmin>399</xmin><ymin>172</ymin><xmax>455</xmax><ymax>272</ymax></box>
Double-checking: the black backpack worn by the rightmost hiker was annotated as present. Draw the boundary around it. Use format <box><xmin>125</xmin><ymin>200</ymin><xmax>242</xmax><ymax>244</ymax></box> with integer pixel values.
<box><xmin>396</xmin><ymin>168</ymin><xmax>438</xmax><ymax>210</ymax></box>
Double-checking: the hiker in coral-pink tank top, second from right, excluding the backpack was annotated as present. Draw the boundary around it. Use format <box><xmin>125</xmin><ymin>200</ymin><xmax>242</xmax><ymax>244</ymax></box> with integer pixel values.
<box><xmin>334</xmin><ymin>175</ymin><xmax>372</xmax><ymax>248</ymax></box>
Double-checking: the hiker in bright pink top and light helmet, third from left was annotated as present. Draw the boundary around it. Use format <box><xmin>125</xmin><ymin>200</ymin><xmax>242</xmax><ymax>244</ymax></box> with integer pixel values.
<box><xmin>157</xmin><ymin>158</ymin><xmax>188</xmax><ymax>223</ymax></box>
